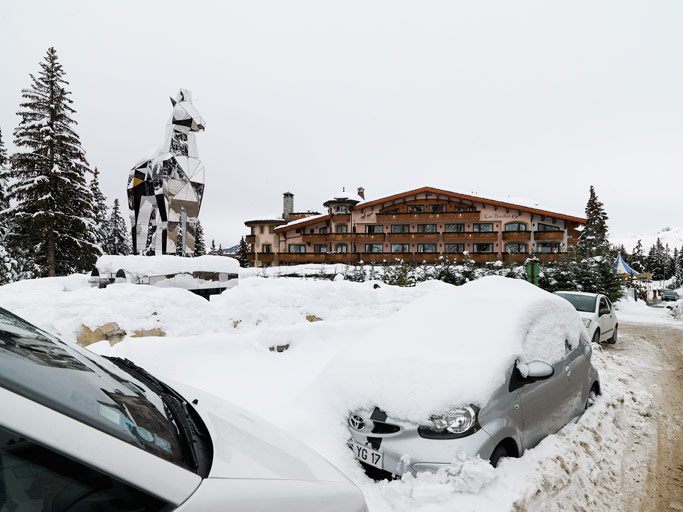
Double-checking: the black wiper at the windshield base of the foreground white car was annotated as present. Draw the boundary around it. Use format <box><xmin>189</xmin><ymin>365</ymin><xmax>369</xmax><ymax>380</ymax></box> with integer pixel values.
<box><xmin>107</xmin><ymin>357</ymin><xmax>199</xmax><ymax>471</ymax></box>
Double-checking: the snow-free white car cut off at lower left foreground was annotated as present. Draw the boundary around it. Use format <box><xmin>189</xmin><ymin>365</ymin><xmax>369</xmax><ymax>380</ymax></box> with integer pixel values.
<box><xmin>0</xmin><ymin>309</ymin><xmax>367</xmax><ymax>512</ymax></box>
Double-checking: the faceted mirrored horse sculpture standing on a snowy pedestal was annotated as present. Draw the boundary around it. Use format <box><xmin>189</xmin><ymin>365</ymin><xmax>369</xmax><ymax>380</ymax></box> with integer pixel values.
<box><xmin>128</xmin><ymin>89</ymin><xmax>204</xmax><ymax>255</ymax></box>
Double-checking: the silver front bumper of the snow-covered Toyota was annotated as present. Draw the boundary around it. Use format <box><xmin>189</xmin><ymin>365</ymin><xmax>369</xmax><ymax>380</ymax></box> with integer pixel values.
<box><xmin>349</xmin><ymin>413</ymin><xmax>495</xmax><ymax>476</ymax></box>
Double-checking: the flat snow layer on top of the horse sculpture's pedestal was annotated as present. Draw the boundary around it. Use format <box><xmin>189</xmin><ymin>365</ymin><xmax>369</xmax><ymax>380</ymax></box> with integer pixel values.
<box><xmin>95</xmin><ymin>255</ymin><xmax>240</xmax><ymax>277</ymax></box>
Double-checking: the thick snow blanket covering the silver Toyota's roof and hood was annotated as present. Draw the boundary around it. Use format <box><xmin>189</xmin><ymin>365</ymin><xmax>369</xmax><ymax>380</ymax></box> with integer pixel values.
<box><xmin>319</xmin><ymin>277</ymin><xmax>584</xmax><ymax>422</ymax></box>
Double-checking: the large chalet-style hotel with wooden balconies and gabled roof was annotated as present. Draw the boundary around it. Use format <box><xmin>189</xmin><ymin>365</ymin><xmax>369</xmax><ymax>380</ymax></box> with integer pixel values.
<box><xmin>245</xmin><ymin>187</ymin><xmax>586</xmax><ymax>267</ymax></box>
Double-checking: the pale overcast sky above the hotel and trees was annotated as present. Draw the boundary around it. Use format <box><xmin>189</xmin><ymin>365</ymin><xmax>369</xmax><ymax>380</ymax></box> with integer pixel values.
<box><xmin>0</xmin><ymin>0</ymin><xmax>683</xmax><ymax>245</ymax></box>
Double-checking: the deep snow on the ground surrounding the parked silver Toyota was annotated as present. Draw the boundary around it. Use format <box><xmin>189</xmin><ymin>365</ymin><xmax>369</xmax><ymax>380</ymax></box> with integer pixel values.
<box><xmin>0</xmin><ymin>276</ymin><xmax>683</xmax><ymax>512</ymax></box>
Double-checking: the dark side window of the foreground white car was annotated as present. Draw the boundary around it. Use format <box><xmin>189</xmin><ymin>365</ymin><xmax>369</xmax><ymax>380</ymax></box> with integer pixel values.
<box><xmin>0</xmin><ymin>428</ymin><xmax>169</xmax><ymax>512</ymax></box>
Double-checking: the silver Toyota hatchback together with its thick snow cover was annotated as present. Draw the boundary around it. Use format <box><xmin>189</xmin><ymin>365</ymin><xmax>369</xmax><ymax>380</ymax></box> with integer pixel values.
<box><xmin>336</xmin><ymin>278</ymin><xmax>600</xmax><ymax>478</ymax></box>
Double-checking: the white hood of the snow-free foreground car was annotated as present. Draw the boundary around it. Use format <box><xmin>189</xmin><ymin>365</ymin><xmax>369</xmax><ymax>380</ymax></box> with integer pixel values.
<box><xmin>169</xmin><ymin>382</ymin><xmax>350</xmax><ymax>484</ymax></box>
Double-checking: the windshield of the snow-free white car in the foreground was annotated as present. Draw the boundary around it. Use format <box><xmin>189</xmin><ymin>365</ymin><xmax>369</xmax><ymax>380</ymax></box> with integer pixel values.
<box><xmin>0</xmin><ymin>308</ymin><xmax>210</xmax><ymax>471</ymax></box>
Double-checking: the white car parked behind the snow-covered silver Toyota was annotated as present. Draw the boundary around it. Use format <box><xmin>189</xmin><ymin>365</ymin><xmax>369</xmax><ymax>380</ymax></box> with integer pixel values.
<box><xmin>555</xmin><ymin>292</ymin><xmax>619</xmax><ymax>344</ymax></box>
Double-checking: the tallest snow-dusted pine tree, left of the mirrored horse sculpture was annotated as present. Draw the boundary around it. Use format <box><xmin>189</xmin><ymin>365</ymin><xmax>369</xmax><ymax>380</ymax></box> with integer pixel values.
<box><xmin>6</xmin><ymin>48</ymin><xmax>99</xmax><ymax>276</ymax></box>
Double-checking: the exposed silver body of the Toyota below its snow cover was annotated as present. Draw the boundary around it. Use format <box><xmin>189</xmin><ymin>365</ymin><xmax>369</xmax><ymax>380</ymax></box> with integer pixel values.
<box><xmin>348</xmin><ymin>336</ymin><xmax>600</xmax><ymax>479</ymax></box>
